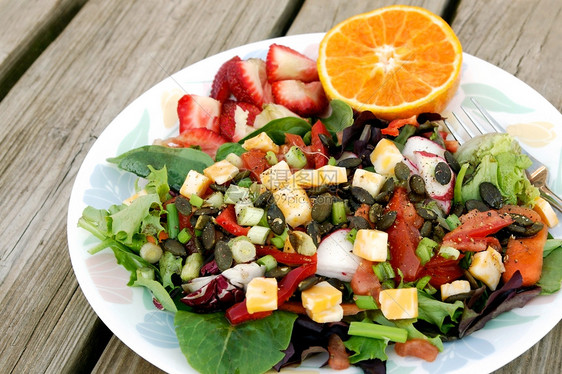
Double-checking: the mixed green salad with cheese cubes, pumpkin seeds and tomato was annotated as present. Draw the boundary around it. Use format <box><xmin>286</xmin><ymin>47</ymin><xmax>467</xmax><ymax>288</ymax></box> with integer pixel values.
<box><xmin>75</xmin><ymin>42</ymin><xmax>560</xmax><ymax>372</ymax></box>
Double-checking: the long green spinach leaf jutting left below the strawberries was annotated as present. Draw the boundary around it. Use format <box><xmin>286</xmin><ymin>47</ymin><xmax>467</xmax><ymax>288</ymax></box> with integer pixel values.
<box><xmin>107</xmin><ymin>145</ymin><xmax>214</xmax><ymax>191</ymax></box>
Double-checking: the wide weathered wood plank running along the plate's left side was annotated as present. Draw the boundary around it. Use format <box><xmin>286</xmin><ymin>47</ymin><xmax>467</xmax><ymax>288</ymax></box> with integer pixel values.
<box><xmin>0</xmin><ymin>0</ymin><xmax>297</xmax><ymax>372</ymax></box>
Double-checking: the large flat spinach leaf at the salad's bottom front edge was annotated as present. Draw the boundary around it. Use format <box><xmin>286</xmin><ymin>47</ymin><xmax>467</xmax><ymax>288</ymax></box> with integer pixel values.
<box><xmin>175</xmin><ymin>310</ymin><xmax>297</xmax><ymax>374</ymax></box>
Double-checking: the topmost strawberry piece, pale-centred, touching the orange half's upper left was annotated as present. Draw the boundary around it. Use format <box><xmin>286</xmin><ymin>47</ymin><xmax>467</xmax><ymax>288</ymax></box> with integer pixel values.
<box><xmin>265</xmin><ymin>44</ymin><xmax>318</xmax><ymax>83</ymax></box>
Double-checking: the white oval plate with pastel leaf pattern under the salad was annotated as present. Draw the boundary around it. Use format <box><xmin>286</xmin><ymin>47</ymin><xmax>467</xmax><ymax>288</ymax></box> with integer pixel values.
<box><xmin>68</xmin><ymin>34</ymin><xmax>562</xmax><ymax>373</ymax></box>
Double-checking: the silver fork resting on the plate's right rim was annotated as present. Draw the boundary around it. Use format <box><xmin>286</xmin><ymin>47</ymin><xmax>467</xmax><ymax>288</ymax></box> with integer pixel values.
<box><xmin>444</xmin><ymin>97</ymin><xmax>562</xmax><ymax>212</ymax></box>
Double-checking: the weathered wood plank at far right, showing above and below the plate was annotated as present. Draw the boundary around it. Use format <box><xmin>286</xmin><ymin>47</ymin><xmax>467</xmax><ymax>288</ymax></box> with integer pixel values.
<box><xmin>452</xmin><ymin>0</ymin><xmax>562</xmax><ymax>374</ymax></box>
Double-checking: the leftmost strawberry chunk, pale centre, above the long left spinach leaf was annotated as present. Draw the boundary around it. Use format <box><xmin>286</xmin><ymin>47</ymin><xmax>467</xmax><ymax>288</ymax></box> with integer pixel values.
<box><xmin>178</xmin><ymin>95</ymin><xmax>221</xmax><ymax>134</ymax></box>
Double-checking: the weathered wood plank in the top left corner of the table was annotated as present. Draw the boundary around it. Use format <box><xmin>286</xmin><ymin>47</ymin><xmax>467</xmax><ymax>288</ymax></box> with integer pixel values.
<box><xmin>0</xmin><ymin>0</ymin><xmax>87</xmax><ymax>100</ymax></box>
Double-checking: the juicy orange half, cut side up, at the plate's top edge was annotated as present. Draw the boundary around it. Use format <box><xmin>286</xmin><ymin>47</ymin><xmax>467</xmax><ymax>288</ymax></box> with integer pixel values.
<box><xmin>318</xmin><ymin>5</ymin><xmax>462</xmax><ymax>120</ymax></box>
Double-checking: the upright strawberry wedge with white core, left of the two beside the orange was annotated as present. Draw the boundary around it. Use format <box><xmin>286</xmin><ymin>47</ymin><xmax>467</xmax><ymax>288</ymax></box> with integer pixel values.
<box><xmin>228</xmin><ymin>58</ymin><xmax>267</xmax><ymax>108</ymax></box>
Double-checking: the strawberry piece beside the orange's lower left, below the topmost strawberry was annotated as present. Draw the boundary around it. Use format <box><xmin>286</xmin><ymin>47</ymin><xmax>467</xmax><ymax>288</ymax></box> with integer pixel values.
<box><xmin>271</xmin><ymin>80</ymin><xmax>328</xmax><ymax>117</ymax></box>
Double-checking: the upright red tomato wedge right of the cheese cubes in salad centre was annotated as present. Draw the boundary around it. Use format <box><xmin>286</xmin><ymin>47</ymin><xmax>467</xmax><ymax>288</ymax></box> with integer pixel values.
<box><xmin>387</xmin><ymin>188</ymin><xmax>423</xmax><ymax>282</ymax></box>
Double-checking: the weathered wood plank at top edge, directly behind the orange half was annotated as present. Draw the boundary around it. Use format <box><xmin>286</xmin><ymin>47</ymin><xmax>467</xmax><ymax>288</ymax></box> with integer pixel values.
<box><xmin>287</xmin><ymin>0</ymin><xmax>447</xmax><ymax>35</ymax></box>
